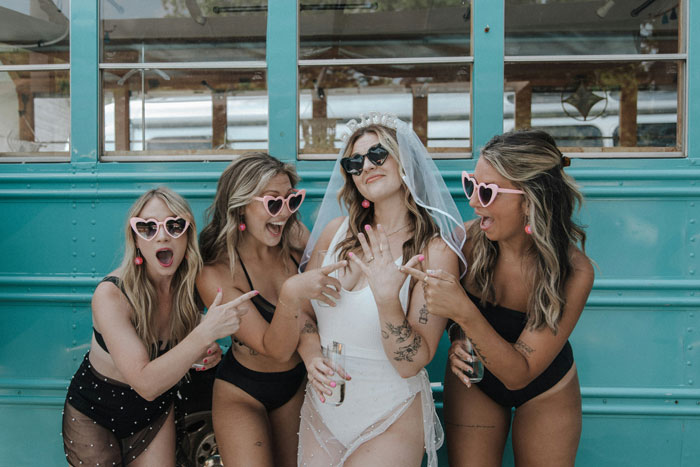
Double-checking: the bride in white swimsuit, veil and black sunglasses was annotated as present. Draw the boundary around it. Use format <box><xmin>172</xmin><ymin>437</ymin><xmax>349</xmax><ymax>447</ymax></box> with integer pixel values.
<box><xmin>298</xmin><ymin>114</ymin><xmax>464</xmax><ymax>466</ymax></box>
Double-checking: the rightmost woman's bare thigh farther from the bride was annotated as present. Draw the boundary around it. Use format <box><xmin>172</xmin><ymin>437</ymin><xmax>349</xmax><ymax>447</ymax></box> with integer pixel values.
<box><xmin>513</xmin><ymin>366</ymin><xmax>581</xmax><ymax>467</ymax></box>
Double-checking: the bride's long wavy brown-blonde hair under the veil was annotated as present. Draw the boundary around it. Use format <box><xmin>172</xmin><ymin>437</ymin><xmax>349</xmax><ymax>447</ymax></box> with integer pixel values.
<box><xmin>335</xmin><ymin>124</ymin><xmax>440</xmax><ymax>264</ymax></box>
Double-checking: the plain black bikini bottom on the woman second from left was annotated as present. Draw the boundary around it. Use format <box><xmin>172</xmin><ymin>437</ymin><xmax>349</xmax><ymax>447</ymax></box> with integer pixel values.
<box><xmin>216</xmin><ymin>347</ymin><xmax>306</xmax><ymax>411</ymax></box>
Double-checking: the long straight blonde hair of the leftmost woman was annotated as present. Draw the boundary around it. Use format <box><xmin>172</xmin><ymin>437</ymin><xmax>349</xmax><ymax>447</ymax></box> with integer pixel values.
<box><xmin>119</xmin><ymin>187</ymin><xmax>202</xmax><ymax>359</ymax></box>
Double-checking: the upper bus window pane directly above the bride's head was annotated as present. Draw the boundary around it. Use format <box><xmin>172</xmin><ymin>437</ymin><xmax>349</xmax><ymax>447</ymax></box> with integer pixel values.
<box><xmin>299</xmin><ymin>0</ymin><xmax>471</xmax><ymax>59</ymax></box>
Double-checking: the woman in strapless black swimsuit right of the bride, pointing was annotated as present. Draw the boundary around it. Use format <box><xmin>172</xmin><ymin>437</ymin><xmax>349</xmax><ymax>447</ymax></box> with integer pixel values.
<box><xmin>402</xmin><ymin>130</ymin><xmax>593</xmax><ymax>467</ymax></box>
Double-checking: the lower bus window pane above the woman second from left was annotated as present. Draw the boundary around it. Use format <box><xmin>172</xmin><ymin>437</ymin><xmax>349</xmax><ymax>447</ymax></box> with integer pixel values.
<box><xmin>103</xmin><ymin>69</ymin><xmax>268</xmax><ymax>159</ymax></box>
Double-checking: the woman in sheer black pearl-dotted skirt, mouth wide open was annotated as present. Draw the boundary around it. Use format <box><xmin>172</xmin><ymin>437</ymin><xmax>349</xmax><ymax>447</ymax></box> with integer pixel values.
<box><xmin>63</xmin><ymin>188</ymin><xmax>257</xmax><ymax>466</ymax></box>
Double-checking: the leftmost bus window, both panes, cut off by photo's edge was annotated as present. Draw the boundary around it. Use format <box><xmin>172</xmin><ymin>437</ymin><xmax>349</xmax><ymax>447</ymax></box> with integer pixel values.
<box><xmin>0</xmin><ymin>0</ymin><xmax>70</xmax><ymax>161</ymax></box>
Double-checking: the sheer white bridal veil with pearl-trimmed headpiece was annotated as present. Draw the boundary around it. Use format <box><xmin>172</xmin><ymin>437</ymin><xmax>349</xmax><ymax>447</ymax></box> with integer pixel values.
<box><xmin>299</xmin><ymin>112</ymin><xmax>467</xmax><ymax>276</ymax></box>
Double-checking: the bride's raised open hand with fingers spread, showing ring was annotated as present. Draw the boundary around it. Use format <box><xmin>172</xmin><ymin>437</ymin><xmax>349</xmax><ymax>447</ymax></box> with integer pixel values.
<box><xmin>348</xmin><ymin>224</ymin><xmax>423</xmax><ymax>303</ymax></box>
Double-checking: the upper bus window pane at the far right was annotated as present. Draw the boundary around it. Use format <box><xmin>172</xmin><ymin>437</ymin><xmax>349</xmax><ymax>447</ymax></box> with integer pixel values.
<box><xmin>505</xmin><ymin>0</ymin><xmax>682</xmax><ymax>56</ymax></box>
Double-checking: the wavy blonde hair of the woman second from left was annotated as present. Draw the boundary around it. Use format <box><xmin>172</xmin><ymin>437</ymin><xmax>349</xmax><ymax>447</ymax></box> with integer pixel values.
<box><xmin>199</xmin><ymin>152</ymin><xmax>299</xmax><ymax>277</ymax></box>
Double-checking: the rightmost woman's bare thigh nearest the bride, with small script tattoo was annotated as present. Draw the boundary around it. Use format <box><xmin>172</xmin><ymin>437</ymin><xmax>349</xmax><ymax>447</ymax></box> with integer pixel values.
<box><xmin>443</xmin><ymin>366</ymin><xmax>511</xmax><ymax>467</ymax></box>
